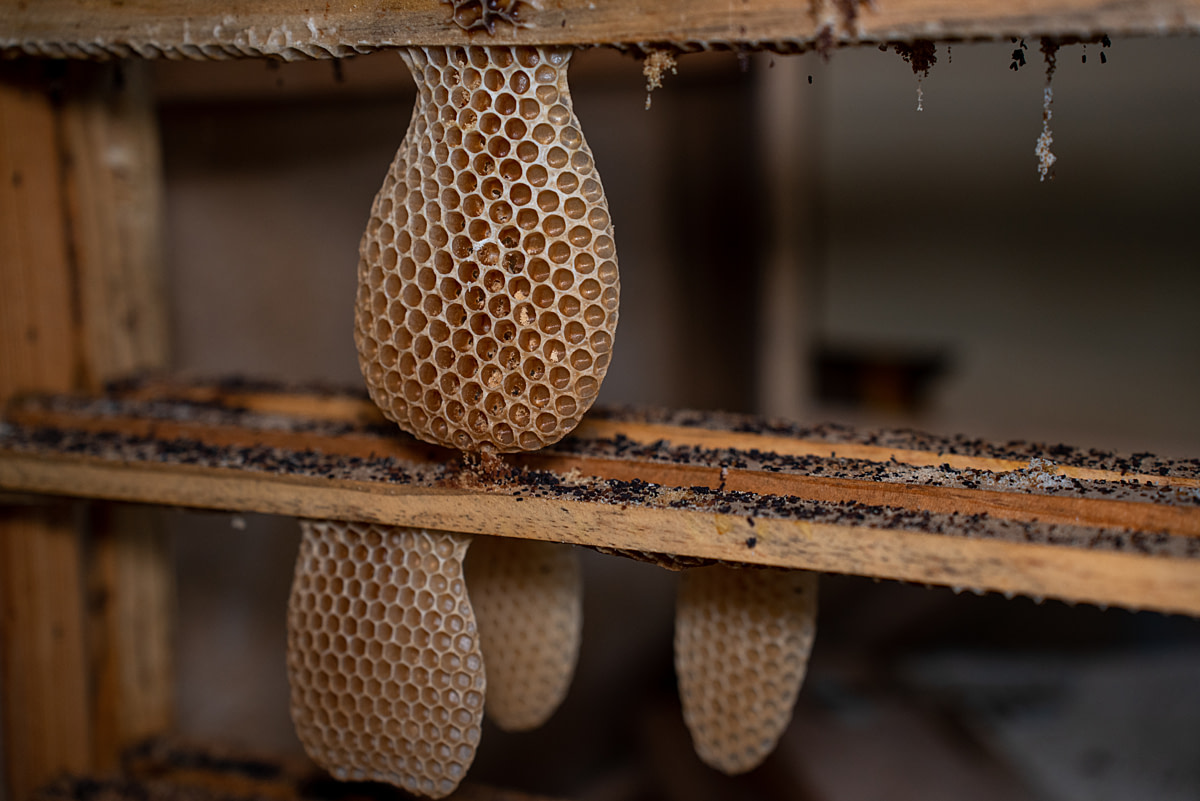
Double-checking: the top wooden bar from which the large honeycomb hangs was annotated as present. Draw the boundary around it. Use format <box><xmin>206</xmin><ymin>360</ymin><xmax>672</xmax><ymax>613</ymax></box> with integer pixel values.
<box><xmin>0</xmin><ymin>0</ymin><xmax>1200</xmax><ymax>60</ymax></box>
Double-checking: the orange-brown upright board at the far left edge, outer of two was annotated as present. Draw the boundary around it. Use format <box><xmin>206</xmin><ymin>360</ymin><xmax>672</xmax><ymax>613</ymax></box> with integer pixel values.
<box><xmin>0</xmin><ymin>64</ymin><xmax>91</xmax><ymax>801</ymax></box>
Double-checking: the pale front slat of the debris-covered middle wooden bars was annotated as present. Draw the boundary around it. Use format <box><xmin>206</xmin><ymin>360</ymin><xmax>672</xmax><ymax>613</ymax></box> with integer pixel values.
<box><xmin>0</xmin><ymin>454</ymin><xmax>1200</xmax><ymax>615</ymax></box>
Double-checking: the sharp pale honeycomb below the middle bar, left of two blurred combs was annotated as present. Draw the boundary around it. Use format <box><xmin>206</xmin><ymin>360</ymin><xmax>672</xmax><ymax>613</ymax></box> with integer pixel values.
<box><xmin>288</xmin><ymin>522</ymin><xmax>486</xmax><ymax>797</ymax></box>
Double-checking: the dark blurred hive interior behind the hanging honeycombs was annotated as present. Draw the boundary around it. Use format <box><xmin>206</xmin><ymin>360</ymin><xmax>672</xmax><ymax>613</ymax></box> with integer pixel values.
<box><xmin>158</xmin><ymin>40</ymin><xmax>1200</xmax><ymax>799</ymax></box>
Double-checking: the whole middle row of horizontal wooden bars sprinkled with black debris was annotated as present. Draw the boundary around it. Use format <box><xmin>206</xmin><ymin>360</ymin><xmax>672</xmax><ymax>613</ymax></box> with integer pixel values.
<box><xmin>0</xmin><ymin>381</ymin><xmax>1200</xmax><ymax>614</ymax></box>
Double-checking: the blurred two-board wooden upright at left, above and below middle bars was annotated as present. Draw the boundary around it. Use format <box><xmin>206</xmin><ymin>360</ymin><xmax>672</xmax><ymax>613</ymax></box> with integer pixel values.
<box><xmin>0</xmin><ymin>61</ymin><xmax>172</xmax><ymax>801</ymax></box>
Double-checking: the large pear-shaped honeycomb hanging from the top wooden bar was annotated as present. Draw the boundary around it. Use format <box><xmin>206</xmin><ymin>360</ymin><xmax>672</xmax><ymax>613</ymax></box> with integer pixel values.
<box><xmin>355</xmin><ymin>47</ymin><xmax>619</xmax><ymax>452</ymax></box>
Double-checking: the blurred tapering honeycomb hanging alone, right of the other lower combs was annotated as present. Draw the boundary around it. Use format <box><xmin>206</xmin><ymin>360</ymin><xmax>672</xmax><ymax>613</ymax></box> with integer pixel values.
<box><xmin>674</xmin><ymin>566</ymin><xmax>817</xmax><ymax>775</ymax></box>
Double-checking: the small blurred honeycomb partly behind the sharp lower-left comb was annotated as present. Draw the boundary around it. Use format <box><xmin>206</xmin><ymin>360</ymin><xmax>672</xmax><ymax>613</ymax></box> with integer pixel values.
<box><xmin>466</xmin><ymin>537</ymin><xmax>583</xmax><ymax>731</ymax></box>
